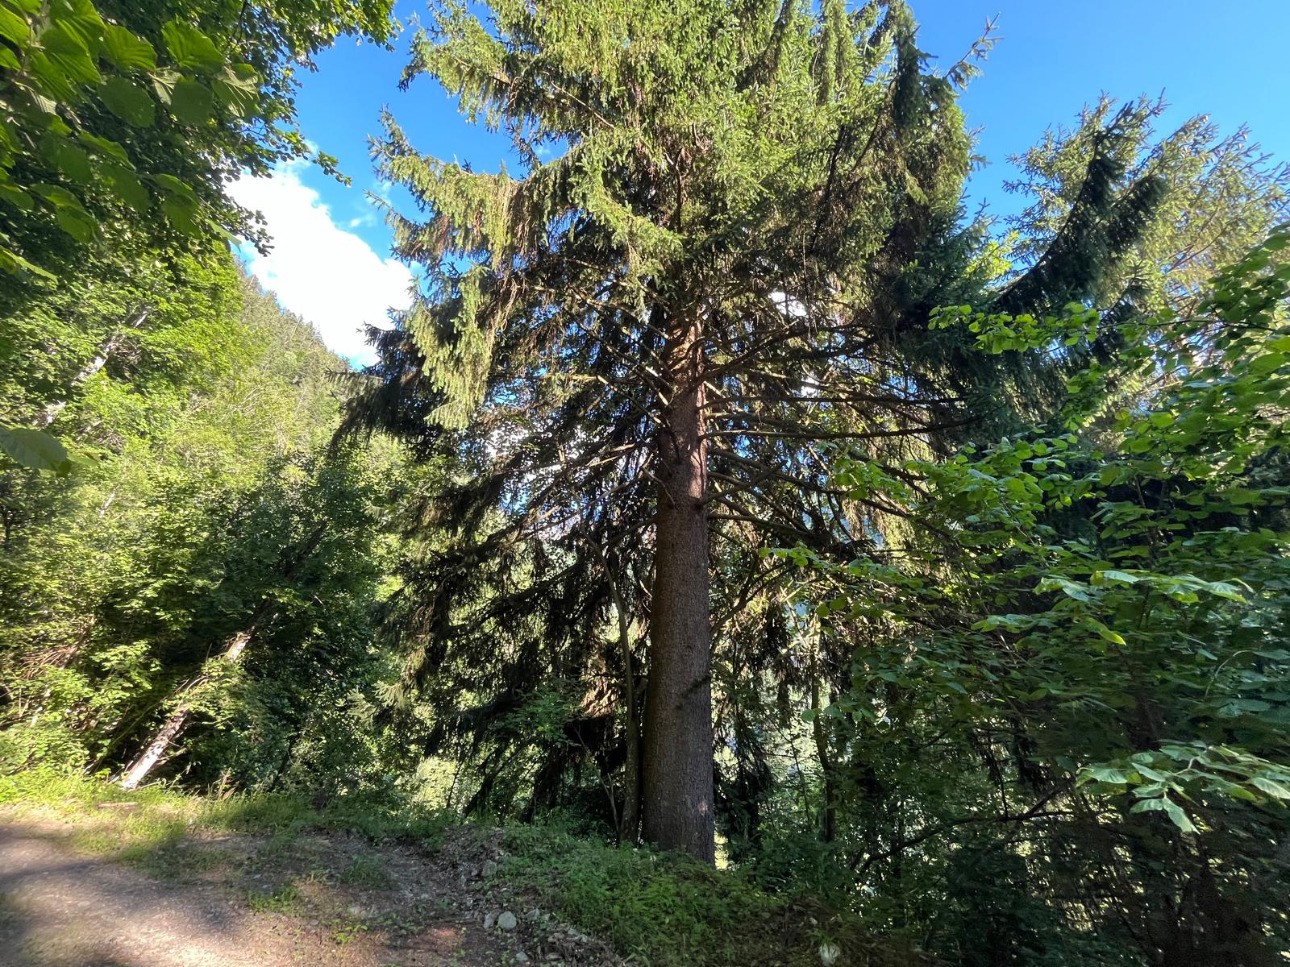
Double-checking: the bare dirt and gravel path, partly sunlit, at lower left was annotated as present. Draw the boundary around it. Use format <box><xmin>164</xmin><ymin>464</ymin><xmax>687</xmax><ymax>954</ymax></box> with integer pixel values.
<box><xmin>0</xmin><ymin>811</ymin><xmax>620</xmax><ymax>967</ymax></box>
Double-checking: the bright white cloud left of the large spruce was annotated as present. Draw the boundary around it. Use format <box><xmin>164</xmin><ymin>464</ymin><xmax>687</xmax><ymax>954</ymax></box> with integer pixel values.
<box><xmin>228</xmin><ymin>161</ymin><xmax>413</xmax><ymax>364</ymax></box>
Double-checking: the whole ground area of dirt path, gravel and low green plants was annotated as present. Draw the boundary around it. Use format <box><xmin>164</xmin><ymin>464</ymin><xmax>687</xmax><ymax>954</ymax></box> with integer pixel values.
<box><xmin>0</xmin><ymin>768</ymin><xmax>908</xmax><ymax>967</ymax></box>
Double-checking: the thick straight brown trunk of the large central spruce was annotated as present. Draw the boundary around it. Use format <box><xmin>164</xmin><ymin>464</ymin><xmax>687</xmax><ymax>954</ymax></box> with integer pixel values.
<box><xmin>642</xmin><ymin>318</ymin><xmax>715</xmax><ymax>863</ymax></box>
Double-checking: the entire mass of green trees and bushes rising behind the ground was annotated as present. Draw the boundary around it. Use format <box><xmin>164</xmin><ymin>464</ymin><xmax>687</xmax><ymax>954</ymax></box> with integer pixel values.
<box><xmin>0</xmin><ymin>0</ymin><xmax>1290</xmax><ymax>966</ymax></box>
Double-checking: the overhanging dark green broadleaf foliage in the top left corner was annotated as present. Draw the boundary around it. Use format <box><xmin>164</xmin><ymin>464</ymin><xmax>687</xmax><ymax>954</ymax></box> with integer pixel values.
<box><xmin>0</xmin><ymin>0</ymin><xmax>397</xmax><ymax>471</ymax></box>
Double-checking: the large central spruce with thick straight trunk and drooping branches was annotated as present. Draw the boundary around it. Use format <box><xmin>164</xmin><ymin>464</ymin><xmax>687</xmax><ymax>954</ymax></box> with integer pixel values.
<box><xmin>351</xmin><ymin>0</ymin><xmax>1161</xmax><ymax>860</ymax></box>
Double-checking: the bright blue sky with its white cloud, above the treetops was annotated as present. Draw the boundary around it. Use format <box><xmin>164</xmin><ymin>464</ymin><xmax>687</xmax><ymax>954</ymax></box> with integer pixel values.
<box><xmin>240</xmin><ymin>0</ymin><xmax>1290</xmax><ymax>360</ymax></box>
